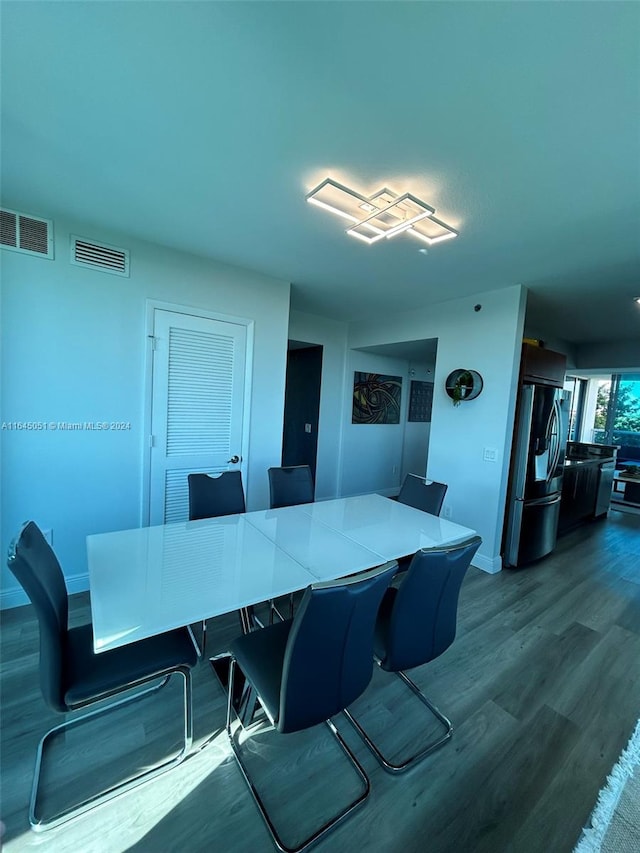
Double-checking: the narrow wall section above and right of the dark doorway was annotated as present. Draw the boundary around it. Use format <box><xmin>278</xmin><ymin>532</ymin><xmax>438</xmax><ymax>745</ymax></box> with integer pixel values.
<box><xmin>289</xmin><ymin>311</ymin><xmax>351</xmax><ymax>500</ymax></box>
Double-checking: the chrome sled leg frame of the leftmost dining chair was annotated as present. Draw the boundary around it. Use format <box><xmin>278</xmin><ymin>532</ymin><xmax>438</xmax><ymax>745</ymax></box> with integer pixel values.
<box><xmin>29</xmin><ymin>668</ymin><xmax>193</xmax><ymax>832</ymax></box>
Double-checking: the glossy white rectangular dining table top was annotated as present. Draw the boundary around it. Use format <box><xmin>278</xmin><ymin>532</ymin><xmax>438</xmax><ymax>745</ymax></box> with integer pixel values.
<box><xmin>87</xmin><ymin>495</ymin><xmax>475</xmax><ymax>652</ymax></box>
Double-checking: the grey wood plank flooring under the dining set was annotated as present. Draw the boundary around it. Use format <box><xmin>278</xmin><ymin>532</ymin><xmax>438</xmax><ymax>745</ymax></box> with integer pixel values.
<box><xmin>0</xmin><ymin>511</ymin><xmax>640</xmax><ymax>853</ymax></box>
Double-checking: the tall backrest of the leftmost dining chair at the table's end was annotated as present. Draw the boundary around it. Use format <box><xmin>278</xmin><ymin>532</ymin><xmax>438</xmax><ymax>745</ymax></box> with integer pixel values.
<box><xmin>7</xmin><ymin>521</ymin><xmax>69</xmax><ymax>711</ymax></box>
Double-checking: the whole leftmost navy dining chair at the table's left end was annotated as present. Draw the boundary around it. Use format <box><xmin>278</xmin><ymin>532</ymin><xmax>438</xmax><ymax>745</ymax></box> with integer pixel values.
<box><xmin>7</xmin><ymin>521</ymin><xmax>198</xmax><ymax>830</ymax></box>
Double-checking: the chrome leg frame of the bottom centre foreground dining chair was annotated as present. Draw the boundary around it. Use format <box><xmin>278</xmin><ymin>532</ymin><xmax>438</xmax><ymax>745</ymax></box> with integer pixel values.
<box><xmin>226</xmin><ymin>658</ymin><xmax>371</xmax><ymax>853</ymax></box>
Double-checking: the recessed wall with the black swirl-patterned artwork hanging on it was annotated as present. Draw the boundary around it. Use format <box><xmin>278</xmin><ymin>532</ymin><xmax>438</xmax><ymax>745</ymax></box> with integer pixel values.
<box><xmin>341</xmin><ymin>351</ymin><xmax>409</xmax><ymax>495</ymax></box>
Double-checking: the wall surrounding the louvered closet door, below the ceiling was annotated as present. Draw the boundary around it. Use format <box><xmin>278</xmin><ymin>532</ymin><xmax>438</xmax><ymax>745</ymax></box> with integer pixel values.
<box><xmin>0</xmin><ymin>220</ymin><xmax>290</xmax><ymax>606</ymax></box>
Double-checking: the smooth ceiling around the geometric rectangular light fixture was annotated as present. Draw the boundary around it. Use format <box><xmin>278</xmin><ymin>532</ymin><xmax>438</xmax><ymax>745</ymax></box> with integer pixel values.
<box><xmin>0</xmin><ymin>0</ymin><xmax>640</xmax><ymax>343</ymax></box>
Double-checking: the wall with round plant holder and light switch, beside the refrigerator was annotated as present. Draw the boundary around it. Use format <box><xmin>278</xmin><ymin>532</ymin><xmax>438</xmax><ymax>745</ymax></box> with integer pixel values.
<box><xmin>349</xmin><ymin>286</ymin><xmax>525</xmax><ymax>571</ymax></box>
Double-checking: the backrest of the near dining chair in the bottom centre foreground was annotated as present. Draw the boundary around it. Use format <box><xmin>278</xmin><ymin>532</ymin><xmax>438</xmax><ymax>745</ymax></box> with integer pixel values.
<box><xmin>277</xmin><ymin>561</ymin><xmax>397</xmax><ymax>732</ymax></box>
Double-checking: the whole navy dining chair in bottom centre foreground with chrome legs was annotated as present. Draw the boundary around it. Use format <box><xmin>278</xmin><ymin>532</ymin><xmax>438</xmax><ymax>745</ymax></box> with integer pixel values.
<box><xmin>222</xmin><ymin>562</ymin><xmax>397</xmax><ymax>853</ymax></box>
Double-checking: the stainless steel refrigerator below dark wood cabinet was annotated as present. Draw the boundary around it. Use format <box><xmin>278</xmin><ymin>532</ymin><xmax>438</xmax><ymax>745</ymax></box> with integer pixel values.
<box><xmin>503</xmin><ymin>384</ymin><xmax>571</xmax><ymax>567</ymax></box>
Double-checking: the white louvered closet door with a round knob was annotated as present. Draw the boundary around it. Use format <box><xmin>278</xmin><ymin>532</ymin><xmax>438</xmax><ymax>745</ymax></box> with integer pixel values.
<box><xmin>149</xmin><ymin>310</ymin><xmax>247</xmax><ymax>524</ymax></box>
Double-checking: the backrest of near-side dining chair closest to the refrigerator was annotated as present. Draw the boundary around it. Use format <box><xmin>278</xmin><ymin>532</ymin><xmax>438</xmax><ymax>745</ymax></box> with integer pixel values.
<box><xmin>375</xmin><ymin>536</ymin><xmax>482</xmax><ymax>672</ymax></box>
